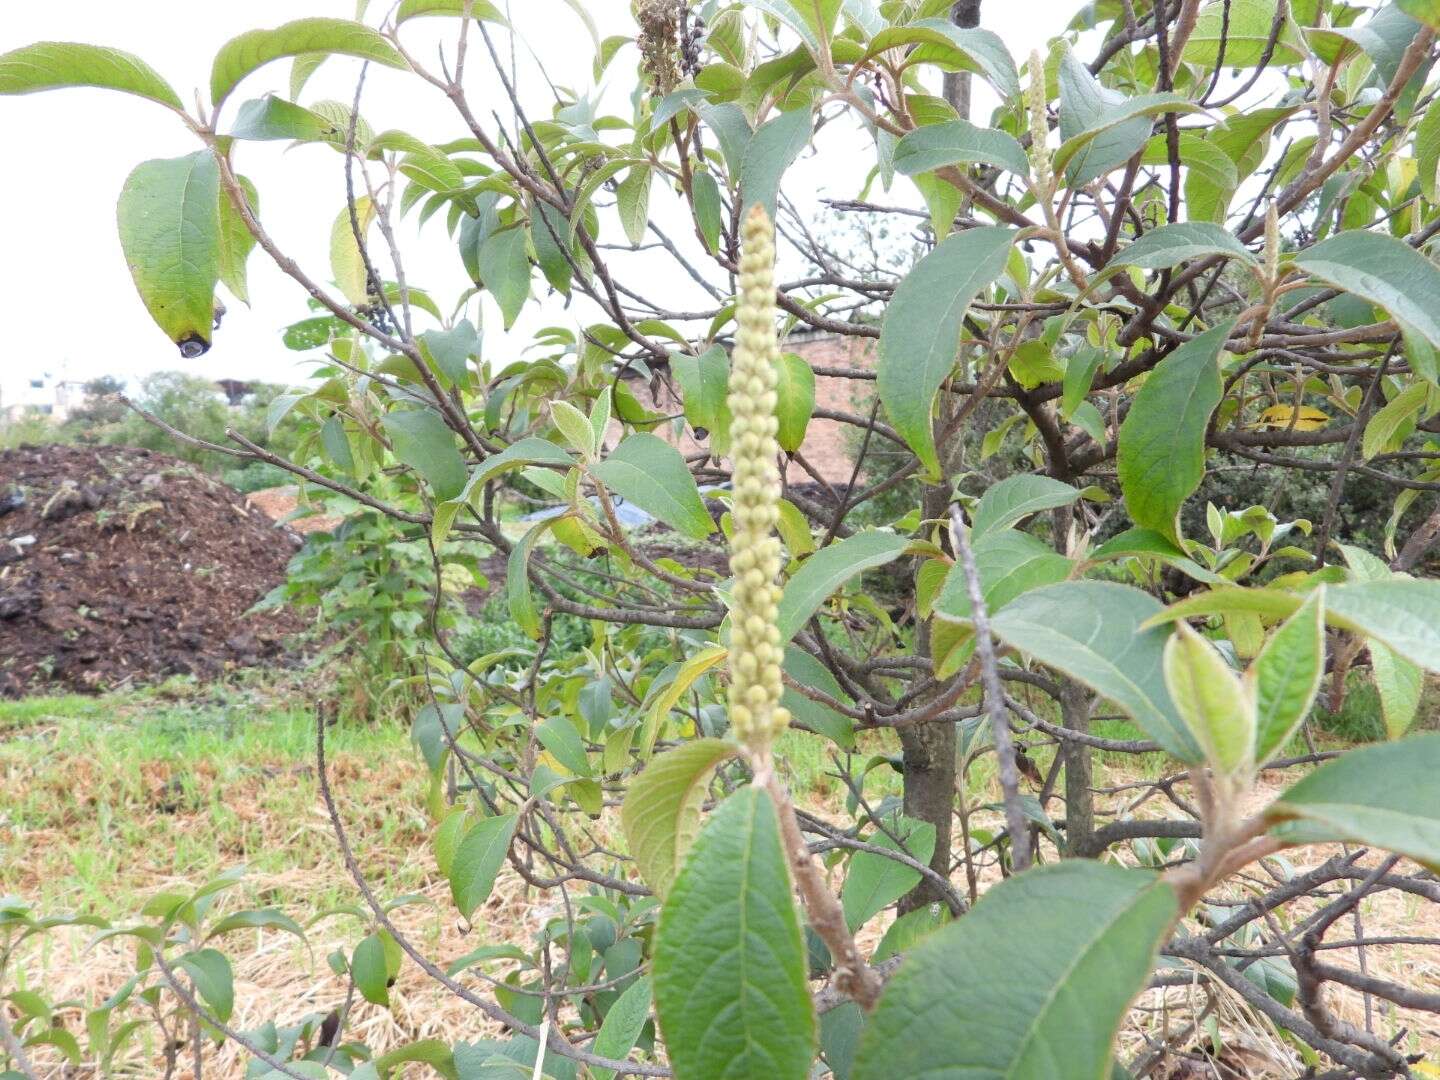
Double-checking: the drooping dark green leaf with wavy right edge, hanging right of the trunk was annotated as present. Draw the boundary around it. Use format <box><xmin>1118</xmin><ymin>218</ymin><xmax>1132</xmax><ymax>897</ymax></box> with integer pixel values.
<box><xmin>1116</xmin><ymin>323</ymin><xmax>1234</xmax><ymax>544</ymax></box>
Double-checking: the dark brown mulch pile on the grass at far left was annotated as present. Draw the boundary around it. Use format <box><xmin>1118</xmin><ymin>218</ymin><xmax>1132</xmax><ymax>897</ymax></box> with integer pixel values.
<box><xmin>0</xmin><ymin>446</ymin><xmax>300</xmax><ymax>697</ymax></box>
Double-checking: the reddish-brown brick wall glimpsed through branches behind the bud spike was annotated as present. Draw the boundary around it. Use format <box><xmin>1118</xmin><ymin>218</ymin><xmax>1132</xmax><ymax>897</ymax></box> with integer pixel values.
<box><xmin>631</xmin><ymin>334</ymin><xmax>876</xmax><ymax>485</ymax></box>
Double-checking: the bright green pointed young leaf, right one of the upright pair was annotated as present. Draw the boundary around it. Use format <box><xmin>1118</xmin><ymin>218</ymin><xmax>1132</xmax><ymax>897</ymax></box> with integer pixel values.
<box><xmin>1246</xmin><ymin>586</ymin><xmax>1325</xmax><ymax>763</ymax></box>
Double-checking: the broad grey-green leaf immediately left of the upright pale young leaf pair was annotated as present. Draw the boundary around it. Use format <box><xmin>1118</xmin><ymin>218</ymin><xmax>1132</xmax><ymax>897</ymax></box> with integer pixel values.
<box><xmin>991</xmin><ymin>582</ymin><xmax>1201</xmax><ymax>763</ymax></box>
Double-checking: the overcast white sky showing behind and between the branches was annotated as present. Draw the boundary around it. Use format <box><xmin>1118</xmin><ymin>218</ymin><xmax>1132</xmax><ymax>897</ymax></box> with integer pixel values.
<box><xmin>0</xmin><ymin>0</ymin><xmax>1059</xmax><ymax>402</ymax></box>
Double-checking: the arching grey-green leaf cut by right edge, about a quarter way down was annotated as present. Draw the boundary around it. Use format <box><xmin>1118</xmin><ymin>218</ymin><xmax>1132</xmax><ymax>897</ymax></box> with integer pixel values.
<box><xmin>1295</xmin><ymin>229</ymin><xmax>1440</xmax><ymax>355</ymax></box>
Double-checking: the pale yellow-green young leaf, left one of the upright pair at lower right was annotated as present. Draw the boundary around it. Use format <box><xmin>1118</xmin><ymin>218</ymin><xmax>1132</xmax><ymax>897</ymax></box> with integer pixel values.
<box><xmin>1164</xmin><ymin>622</ymin><xmax>1256</xmax><ymax>776</ymax></box>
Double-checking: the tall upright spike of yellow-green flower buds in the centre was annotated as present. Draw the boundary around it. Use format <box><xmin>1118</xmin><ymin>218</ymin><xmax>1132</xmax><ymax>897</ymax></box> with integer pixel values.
<box><xmin>729</xmin><ymin>206</ymin><xmax>791</xmax><ymax>752</ymax></box>
